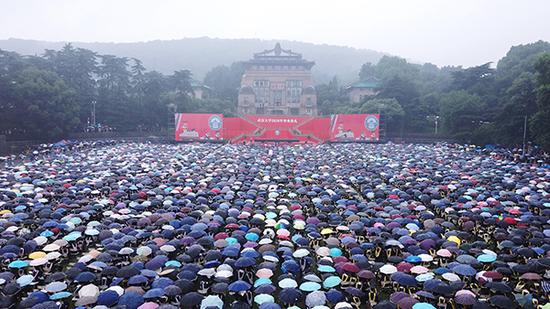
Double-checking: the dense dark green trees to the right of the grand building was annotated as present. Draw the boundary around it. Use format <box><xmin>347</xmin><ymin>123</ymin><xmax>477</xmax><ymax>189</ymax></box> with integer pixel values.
<box><xmin>317</xmin><ymin>41</ymin><xmax>550</xmax><ymax>149</ymax></box>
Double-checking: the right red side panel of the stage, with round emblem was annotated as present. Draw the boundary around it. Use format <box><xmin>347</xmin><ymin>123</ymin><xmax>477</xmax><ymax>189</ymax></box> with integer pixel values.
<box><xmin>330</xmin><ymin>114</ymin><xmax>380</xmax><ymax>141</ymax></box>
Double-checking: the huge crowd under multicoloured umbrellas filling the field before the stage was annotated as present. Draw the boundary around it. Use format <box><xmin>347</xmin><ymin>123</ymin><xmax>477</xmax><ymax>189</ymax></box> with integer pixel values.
<box><xmin>0</xmin><ymin>143</ymin><xmax>550</xmax><ymax>309</ymax></box>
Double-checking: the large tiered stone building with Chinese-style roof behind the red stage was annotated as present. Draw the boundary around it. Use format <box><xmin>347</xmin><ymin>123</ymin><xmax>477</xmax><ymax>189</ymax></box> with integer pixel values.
<box><xmin>237</xmin><ymin>43</ymin><xmax>317</xmax><ymax>116</ymax></box>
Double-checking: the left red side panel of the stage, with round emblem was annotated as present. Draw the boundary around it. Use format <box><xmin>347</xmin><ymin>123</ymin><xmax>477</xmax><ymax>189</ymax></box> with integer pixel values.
<box><xmin>176</xmin><ymin>114</ymin><xmax>223</xmax><ymax>141</ymax></box>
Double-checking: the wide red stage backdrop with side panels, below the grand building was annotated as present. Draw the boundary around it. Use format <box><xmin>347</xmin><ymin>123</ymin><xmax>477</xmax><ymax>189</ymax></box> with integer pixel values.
<box><xmin>175</xmin><ymin>114</ymin><xmax>380</xmax><ymax>144</ymax></box>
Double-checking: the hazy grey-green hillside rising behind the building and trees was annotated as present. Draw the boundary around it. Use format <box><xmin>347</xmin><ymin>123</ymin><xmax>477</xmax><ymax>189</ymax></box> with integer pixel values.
<box><xmin>0</xmin><ymin>38</ymin><xmax>384</xmax><ymax>83</ymax></box>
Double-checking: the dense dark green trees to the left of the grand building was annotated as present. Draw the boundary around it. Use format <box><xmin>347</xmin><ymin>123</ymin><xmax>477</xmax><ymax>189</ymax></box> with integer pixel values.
<box><xmin>0</xmin><ymin>44</ymin><xmax>226</xmax><ymax>139</ymax></box>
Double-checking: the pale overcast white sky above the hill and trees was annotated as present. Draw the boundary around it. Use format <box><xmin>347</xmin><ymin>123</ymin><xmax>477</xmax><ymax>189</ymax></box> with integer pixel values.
<box><xmin>0</xmin><ymin>0</ymin><xmax>550</xmax><ymax>66</ymax></box>
